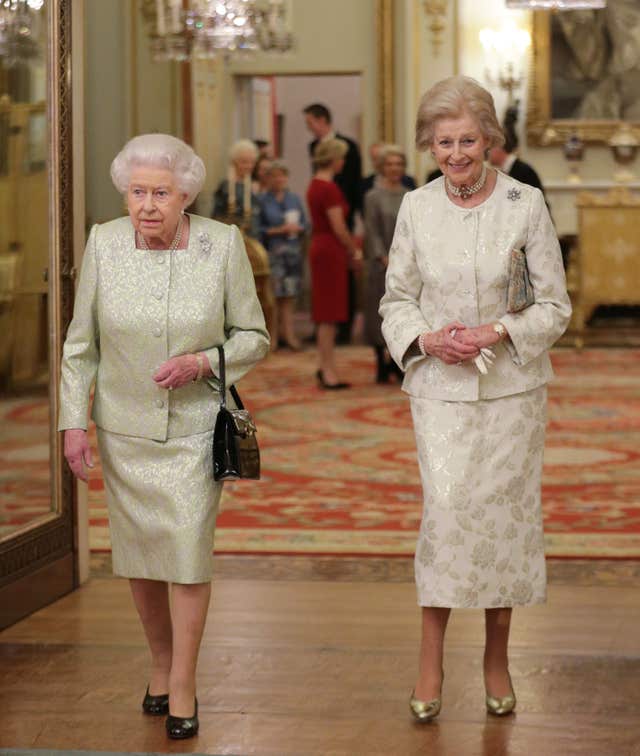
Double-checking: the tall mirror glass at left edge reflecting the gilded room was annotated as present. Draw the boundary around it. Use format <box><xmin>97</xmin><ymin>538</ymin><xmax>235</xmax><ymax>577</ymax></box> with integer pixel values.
<box><xmin>0</xmin><ymin>0</ymin><xmax>53</xmax><ymax>540</ymax></box>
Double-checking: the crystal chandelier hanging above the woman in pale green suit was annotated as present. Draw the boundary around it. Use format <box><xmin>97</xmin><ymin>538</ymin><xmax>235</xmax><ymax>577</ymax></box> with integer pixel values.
<box><xmin>142</xmin><ymin>0</ymin><xmax>293</xmax><ymax>61</ymax></box>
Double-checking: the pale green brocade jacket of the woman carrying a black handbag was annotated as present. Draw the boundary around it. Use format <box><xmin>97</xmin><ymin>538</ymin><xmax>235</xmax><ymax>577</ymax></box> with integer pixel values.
<box><xmin>58</xmin><ymin>215</ymin><xmax>269</xmax><ymax>441</ymax></box>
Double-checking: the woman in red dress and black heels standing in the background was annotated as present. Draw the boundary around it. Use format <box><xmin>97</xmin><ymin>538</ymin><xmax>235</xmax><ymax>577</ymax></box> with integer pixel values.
<box><xmin>307</xmin><ymin>139</ymin><xmax>362</xmax><ymax>389</ymax></box>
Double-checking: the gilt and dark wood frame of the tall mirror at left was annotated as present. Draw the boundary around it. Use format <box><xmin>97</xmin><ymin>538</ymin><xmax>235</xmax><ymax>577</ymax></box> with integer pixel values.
<box><xmin>0</xmin><ymin>0</ymin><xmax>78</xmax><ymax>628</ymax></box>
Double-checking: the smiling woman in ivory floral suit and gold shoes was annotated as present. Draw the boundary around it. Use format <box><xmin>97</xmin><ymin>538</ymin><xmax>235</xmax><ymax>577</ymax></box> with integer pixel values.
<box><xmin>380</xmin><ymin>77</ymin><xmax>571</xmax><ymax>722</ymax></box>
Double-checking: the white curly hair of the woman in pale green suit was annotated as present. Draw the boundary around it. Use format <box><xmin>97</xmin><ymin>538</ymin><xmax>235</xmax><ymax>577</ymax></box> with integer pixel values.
<box><xmin>111</xmin><ymin>134</ymin><xmax>206</xmax><ymax>205</ymax></box>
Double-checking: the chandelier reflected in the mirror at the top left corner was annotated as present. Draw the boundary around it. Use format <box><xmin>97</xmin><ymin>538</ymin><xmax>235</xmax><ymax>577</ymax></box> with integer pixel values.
<box><xmin>0</xmin><ymin>0</ymin><xmax>44</xmax><ymax>68</ymax></box>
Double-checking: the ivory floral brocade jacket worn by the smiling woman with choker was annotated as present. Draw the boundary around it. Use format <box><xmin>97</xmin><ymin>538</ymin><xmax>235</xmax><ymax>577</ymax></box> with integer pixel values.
<box><xmin>380</xmin><ymin>172</ymin><xmax>571</xmax><ymax>401</ymax></box>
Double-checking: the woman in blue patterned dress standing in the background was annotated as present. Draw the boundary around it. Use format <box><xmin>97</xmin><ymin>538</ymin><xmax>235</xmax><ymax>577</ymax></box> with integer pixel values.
<box><xmin>260</xmin><ymin>162</ymin><xmax>307</xmax><ymax>351</ymax></box>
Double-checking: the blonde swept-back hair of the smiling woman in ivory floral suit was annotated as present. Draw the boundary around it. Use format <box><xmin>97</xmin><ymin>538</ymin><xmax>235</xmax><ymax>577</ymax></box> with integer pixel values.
<box><xmin>416</xmin><ymin>76</ymin><xmax>504</xmax><ymax>151</ymax></box>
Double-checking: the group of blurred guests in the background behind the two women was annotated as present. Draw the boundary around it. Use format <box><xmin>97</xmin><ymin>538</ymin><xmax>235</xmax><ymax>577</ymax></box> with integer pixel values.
<box><xmin>212</xmin><ymin>103</ymin><xmax>542</xmax><ymax>390</ymax></box>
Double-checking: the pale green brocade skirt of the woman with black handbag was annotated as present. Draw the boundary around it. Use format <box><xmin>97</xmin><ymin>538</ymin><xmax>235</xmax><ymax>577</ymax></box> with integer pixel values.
<box><xmin>98</xmin><ymin>428</ymin><xmax>222</xmax><ymax>583</ymax></box>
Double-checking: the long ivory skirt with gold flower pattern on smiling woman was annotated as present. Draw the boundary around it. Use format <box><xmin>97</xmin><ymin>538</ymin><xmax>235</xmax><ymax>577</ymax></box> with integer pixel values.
<box><xmin>411</xmin><ymin>386</ymin><xmax>547</xmax><ymax>609</ymax></box>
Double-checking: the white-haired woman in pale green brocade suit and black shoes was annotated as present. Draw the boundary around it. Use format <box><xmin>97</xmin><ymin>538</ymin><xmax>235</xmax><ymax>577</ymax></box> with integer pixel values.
<box><xmin>58</xmin><ymin>134</ymin><xmax>269</xmax><ymax>738</ymax></box>
